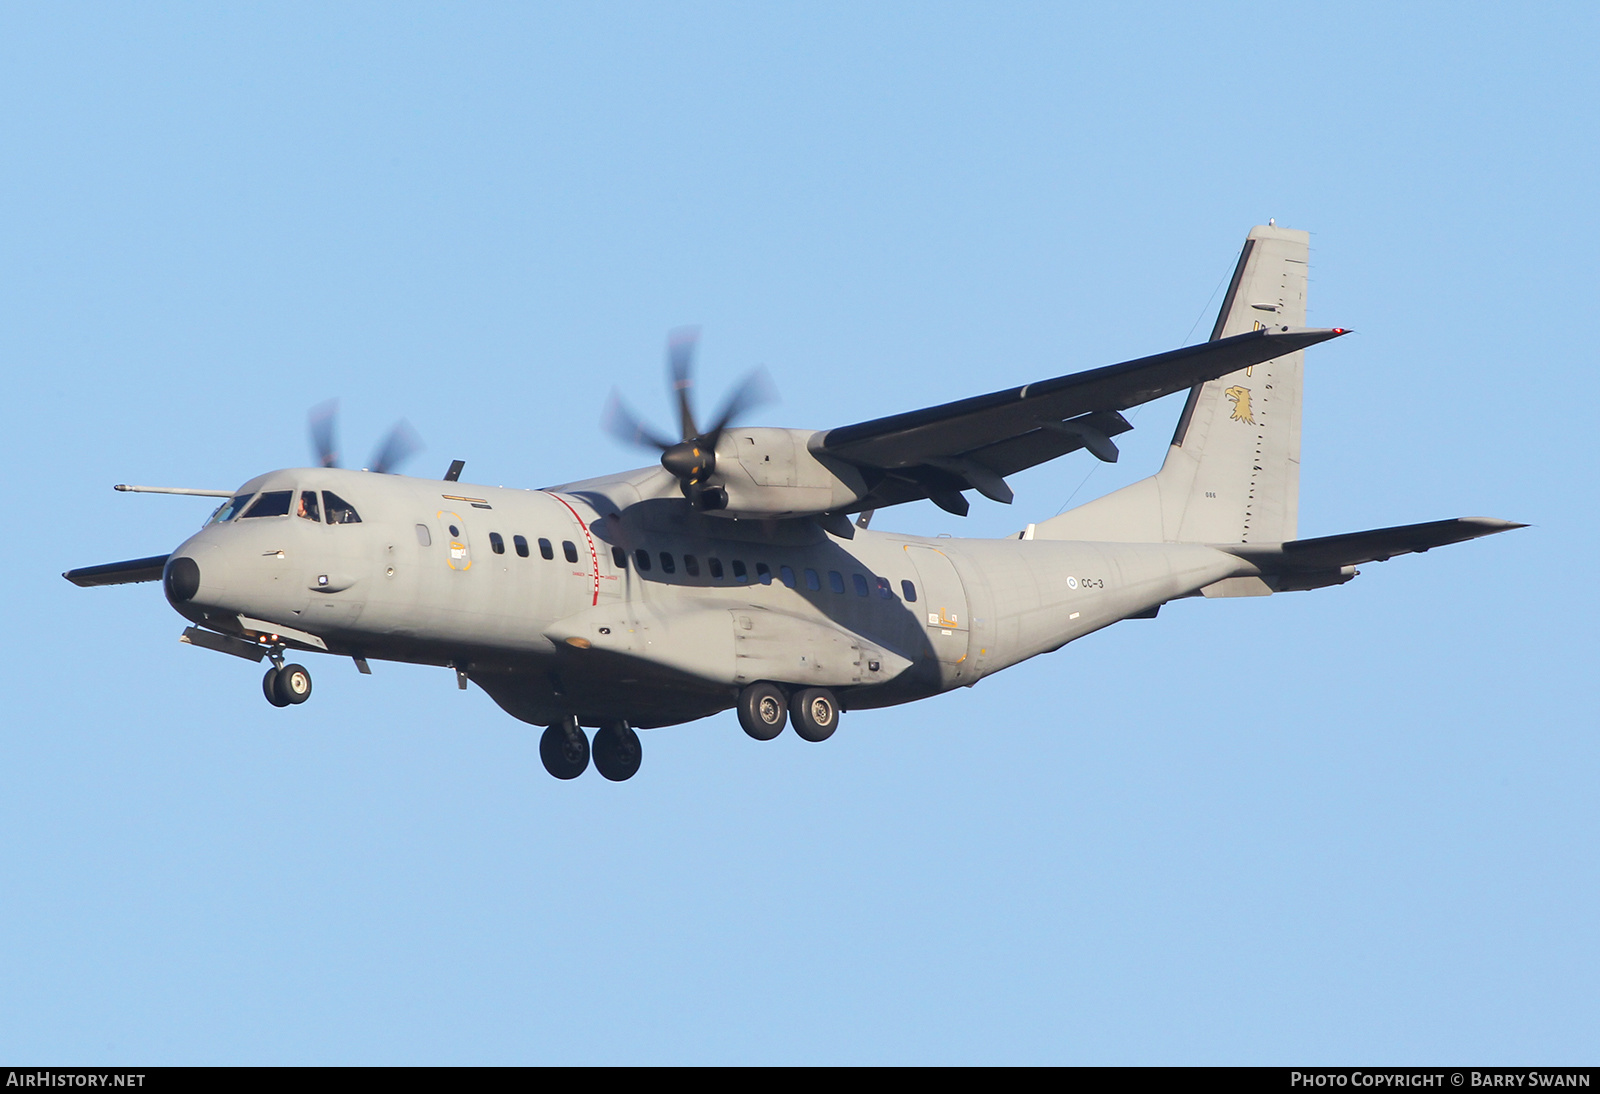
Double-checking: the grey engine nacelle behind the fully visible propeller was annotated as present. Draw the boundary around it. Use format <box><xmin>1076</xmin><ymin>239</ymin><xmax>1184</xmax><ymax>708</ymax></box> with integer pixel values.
<box><xmin>702</xmin><ymin>429</ymin><xmax>869</xmax><ymax>517</ymax></box>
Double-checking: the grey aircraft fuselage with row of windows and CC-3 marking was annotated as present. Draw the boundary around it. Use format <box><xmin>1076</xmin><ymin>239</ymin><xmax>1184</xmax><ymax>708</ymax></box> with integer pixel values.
<box><xmin>166</xmin><ymin>469</ymin><xmax>1259</xmax><ymax>728</ymax></box>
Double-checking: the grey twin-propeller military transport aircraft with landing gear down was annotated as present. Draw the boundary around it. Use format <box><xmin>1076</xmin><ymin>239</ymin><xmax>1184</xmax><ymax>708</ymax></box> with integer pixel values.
<box><xmin>64</xmin><ymin>224</ymin><xmax>1522</xmax><ymax>781</ymax></box>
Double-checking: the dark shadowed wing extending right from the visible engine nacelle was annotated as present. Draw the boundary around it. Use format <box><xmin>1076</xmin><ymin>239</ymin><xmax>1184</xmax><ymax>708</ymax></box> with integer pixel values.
<box><xmin>811</xmin><ymin>326</ymin><xmax>1346</xmax><ymax>512</ymax></box>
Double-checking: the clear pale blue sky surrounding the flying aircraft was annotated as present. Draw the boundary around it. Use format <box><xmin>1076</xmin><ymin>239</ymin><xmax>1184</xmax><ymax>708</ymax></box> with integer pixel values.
<box><xmin>0</xmin><ymin>3</ymin><xmax>1600</xmax><ymax>1064</ymax></box>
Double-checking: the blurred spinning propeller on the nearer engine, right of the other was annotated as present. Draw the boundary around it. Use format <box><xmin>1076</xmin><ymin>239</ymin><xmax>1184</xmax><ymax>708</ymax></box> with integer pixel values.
<box><xmin>602</xmin><ymin>326</ymin><xmax>778</xmax><ymax>509</ymax></box>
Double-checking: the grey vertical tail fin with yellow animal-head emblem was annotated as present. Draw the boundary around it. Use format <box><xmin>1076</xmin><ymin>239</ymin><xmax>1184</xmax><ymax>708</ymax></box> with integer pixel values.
<box><xmin>1034</xmin><ymin>224</ymin><xmax>1310</xmax><ymax>544</ymax></box>
